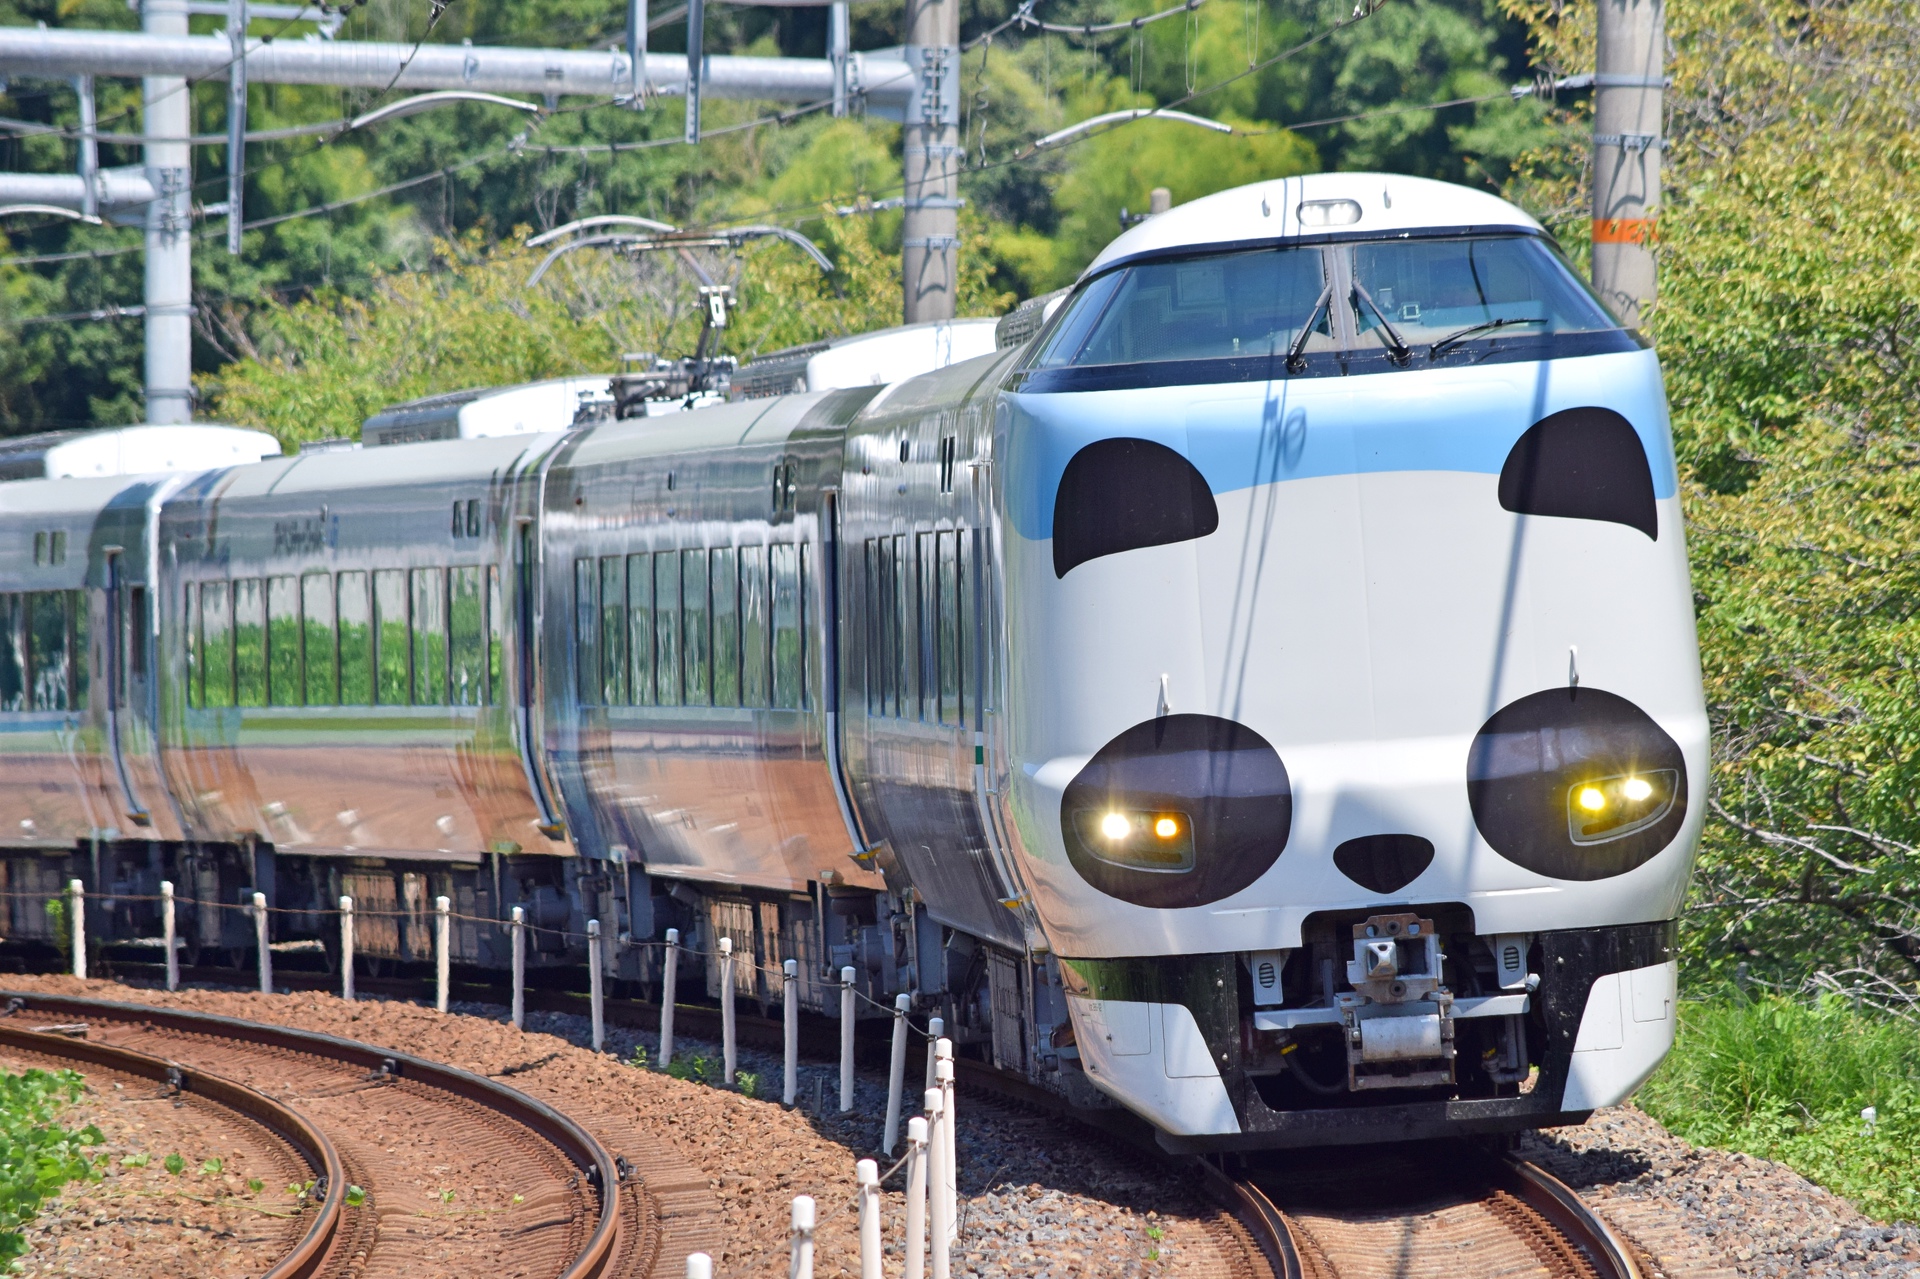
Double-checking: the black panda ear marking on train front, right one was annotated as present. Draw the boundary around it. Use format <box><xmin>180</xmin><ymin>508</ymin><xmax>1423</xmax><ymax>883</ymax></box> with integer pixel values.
<box><xmin>1497</xmin><ymin>407</ymin><xmax>1661</xmax><ymax>533</ymax></box>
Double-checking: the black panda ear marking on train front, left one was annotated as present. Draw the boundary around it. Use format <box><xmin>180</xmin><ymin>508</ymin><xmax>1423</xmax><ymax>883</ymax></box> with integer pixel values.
<box><xmin>1054</xmin><ymin>438</ymin><xmax>1219</xmax><ymax>578</ymax></box>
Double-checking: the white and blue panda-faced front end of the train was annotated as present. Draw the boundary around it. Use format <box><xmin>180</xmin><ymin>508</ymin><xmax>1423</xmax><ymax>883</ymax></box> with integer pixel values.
<box><xmin>998</xmin><ymin>175</ymin><xmax>1707</xmax><ymax>1141</ymax></box>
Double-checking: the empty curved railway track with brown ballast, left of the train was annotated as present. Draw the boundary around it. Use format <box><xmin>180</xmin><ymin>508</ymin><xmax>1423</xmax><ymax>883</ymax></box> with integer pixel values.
<box><xmin>0</xmin><ymin>991</ymin><xmax>629</xmax><ymax>1279</ymax></box>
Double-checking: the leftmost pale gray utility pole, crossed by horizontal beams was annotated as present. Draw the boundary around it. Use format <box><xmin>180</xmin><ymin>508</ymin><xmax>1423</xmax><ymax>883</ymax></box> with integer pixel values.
<box><xmin>140</xmin><ymin>0</ymin><xmax>194</xmax><ymax>424</ymax></box>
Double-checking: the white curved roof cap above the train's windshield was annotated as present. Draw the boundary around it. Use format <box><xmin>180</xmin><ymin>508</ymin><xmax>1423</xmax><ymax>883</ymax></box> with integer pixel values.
<box><xmin>1085</xmin><ymin>173</ymin><xmax>1542</xmax><ymax>275</ymax></box>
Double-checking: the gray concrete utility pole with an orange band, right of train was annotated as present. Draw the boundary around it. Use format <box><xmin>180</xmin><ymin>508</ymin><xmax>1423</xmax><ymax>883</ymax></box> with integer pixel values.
<box><xmin>1594</xmin><ymin>0</ymin><xmax>1667</xmax><ymax>326</ymax></box>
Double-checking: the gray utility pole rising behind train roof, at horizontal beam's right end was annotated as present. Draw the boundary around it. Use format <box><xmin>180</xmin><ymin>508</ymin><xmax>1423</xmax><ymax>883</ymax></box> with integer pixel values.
<box><xmin>900</xmin><ymin>0</ymin><xmax>960</xmax><ymax>325</ymax></box>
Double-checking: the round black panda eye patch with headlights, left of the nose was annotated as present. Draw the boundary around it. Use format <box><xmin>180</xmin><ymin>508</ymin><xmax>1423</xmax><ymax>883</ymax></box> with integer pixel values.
<box><xmin>1060</xmin><ymin>714</ymin><xmax>1294</xmax><ymax>908</ymax></box>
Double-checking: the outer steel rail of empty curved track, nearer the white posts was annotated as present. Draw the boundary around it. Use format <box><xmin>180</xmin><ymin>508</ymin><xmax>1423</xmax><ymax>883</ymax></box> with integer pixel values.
<box><xmin>0</xmin><ymin>991</ymin><xmax>620</xmax><ymax>1279</ymax></box>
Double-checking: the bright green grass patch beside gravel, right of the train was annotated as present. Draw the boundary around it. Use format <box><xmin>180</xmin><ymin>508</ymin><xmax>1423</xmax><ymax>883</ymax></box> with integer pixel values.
<box><xmin>1638</xmin><ymin>991</ymin><xmax>1920</xmax><ymax>1221</ymax></box>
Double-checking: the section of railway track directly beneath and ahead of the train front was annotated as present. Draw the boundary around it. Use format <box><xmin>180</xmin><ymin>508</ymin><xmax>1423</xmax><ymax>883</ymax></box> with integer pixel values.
<box><xmin>1208</xmin><ymin>1146</ymin><xmax>1642</xmax><ymax>1279</ymax></box>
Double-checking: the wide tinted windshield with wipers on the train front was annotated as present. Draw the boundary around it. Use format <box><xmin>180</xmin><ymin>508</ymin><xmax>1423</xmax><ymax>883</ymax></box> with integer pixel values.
<box><xmin>1029</xmin><ymin>234</ymin><xmax>1620</xmax><ymax>373</ymax></box>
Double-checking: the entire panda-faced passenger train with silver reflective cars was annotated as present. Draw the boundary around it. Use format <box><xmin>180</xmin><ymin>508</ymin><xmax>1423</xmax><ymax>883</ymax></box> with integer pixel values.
<box><xmin>0</xmin><ymin>173</ymin><xmax>1707</xmax><ymax>1152</ymax></box>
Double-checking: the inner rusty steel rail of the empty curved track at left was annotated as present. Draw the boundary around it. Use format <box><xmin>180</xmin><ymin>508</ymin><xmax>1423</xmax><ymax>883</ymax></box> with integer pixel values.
<box><xmin>0</xmin><ymin>1024</ymin><xmax>348</xmax><ymax>1279</ymax></box>
